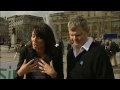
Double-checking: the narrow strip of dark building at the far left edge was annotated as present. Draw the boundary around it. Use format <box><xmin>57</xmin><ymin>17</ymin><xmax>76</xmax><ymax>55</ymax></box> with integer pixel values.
<box><xmin>0</xmin><ymin>17</ymin><xmax>9</xmax><ymax>43</ymax></box>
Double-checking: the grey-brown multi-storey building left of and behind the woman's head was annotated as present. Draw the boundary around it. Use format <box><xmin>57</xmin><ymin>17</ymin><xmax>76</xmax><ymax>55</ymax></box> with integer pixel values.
<box><xmin>7</xmin><ymin>15</ymin><xmax>44</xmax><ymax>42</ymax></box>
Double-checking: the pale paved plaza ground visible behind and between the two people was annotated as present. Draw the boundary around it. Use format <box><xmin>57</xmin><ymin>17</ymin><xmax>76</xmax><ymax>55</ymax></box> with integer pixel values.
<box><xmin>0</xmin><ymin>46</ymin><xmax>120</xmax><ymax>79</ymax></box>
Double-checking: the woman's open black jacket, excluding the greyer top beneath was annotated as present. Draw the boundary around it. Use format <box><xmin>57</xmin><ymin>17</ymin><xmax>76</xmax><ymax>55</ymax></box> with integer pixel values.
<box><xmin>15</xmin><ymin>47</ymin><xmax>64</xmax><ymax>79</ymax></box>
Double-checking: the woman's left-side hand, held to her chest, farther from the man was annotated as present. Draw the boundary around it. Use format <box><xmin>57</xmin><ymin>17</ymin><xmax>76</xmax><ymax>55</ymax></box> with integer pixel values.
<box><xmin>17</xmin><ymin>60</ymin><xmax>37</xmax><ymax>76</ymax></box>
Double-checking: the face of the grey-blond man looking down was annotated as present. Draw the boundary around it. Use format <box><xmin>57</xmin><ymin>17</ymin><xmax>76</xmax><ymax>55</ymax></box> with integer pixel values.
<box><xmin>69</xmin><ymin>27</ymin><xmax>88</xmax><ymax>46</ymax></box>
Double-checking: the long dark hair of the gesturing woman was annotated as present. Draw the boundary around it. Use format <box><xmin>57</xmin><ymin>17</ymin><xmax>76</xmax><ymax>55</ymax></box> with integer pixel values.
<box><xmin>29</xmin><ymin>23</ymin><xmax>56</xmax><ymax>56</ymax></box>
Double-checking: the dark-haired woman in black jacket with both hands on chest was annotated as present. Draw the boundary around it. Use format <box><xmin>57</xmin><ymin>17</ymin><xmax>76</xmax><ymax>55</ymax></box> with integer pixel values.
<box><xmin>16</xmin><ymin>23</ymin><xmax>63</xmax><ymax>79</ymax></box>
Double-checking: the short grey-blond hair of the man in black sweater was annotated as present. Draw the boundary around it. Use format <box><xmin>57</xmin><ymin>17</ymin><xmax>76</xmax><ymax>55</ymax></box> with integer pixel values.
<box><xmin>68</xmin><ymin>16</ymin><xmax>88</xmax><ymax>30</ymax></box>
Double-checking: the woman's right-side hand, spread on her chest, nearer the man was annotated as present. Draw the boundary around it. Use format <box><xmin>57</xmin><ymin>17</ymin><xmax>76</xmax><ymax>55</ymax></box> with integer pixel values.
<box><xmin>38</xmin><ymin>60</ymin><xmax>57</xmax><ymax>78</ymax></box>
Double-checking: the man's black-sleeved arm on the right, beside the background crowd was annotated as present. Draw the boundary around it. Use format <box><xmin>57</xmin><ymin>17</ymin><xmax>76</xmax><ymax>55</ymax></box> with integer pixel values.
<box><xmin>94</xmin><ymin>47</ymin><xmax>114</xmax><ymax>79</ymax></box>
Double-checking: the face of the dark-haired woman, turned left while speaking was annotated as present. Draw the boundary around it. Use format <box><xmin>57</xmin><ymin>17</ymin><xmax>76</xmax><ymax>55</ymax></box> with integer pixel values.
<box><xmin>31</xmin><ymin>32</ymin><xmax>45</xmax><ymax>51</ymax></box>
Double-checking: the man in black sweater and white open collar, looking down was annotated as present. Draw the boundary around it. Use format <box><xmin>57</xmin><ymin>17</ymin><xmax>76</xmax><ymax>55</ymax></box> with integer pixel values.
<box><xmin>67</xmin><ymin>16</ymin><xmax>114</xmax><ymax>79</ymax></box>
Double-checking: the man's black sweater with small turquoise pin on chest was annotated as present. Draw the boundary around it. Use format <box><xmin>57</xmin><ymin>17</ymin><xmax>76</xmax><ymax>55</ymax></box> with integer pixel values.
<box><xmin>67</xmin><ymin>42</ymin><xmax>114</xmax><ymax>79</ymax></box>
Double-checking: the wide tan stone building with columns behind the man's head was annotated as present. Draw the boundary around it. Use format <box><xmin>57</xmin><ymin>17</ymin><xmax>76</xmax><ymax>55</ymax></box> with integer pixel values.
<box><xmin>50</xmin><ymin>11</ymin><xmax>120</xmax><ymax>41</ymax></box>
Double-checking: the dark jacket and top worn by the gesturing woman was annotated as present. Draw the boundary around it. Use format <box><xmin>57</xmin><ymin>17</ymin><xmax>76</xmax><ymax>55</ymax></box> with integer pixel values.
<box><xmin>15</xmin><ymin>46</ymin><xmax>64</xmax><ymax>79</ymax></box>
